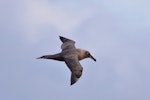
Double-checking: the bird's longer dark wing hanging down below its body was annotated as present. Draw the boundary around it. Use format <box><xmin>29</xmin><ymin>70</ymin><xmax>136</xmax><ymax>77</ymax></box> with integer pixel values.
<box><xmin>65</xmin><ymin>54</ymin><xmax>83</xmax><ymax>85</ymax></box>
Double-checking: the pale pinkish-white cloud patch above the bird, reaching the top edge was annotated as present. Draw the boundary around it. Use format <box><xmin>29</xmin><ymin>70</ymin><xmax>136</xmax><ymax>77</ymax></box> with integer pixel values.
<box><xmin>22</xmin><ymin>0</ymin><xmax>94</xmax><ymax>44</ymax></box>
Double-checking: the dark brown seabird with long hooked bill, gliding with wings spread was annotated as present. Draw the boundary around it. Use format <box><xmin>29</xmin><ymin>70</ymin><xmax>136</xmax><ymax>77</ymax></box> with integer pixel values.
<box><xmin>37</xmin><ymin>36</ymin><xmax>96</xmax><ymax>85</ymax></box>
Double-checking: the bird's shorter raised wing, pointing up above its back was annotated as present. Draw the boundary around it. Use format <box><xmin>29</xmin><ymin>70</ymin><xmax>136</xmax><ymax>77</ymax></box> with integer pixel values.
<box><xmin>59</xmin><ymin>36</ymin><xmax>75</xmax><ymax>51</ymax></box>
